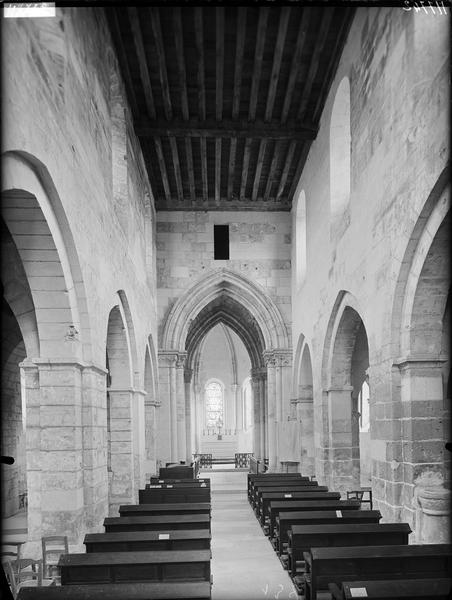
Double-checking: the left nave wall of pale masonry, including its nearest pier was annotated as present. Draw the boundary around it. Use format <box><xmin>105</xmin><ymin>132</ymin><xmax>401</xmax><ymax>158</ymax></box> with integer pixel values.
<box><xmin>2</xmin><ymin>8</ymin><xmax>157</xmax><ymax>543</ymax></box>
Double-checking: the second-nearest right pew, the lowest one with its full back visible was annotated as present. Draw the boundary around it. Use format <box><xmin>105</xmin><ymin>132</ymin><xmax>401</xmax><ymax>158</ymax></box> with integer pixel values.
<box><xmin>300</xmin><ymin>544</ymin><xmax>452</xmax><ymax>600</ymax></box>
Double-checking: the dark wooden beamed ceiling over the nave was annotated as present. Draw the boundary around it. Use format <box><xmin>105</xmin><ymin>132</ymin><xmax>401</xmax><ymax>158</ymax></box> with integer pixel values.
<box><xmin>106</xmin><ymin>6</ymin><xmax>354</xmax><ymax>210</ymax></box>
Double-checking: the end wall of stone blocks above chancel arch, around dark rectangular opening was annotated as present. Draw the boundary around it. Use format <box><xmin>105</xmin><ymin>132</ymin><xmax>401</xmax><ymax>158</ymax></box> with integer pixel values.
<box><xmin>157</xmin><ymin>211</ymin><xmax>291</xmax><ymax>338</ymax></box>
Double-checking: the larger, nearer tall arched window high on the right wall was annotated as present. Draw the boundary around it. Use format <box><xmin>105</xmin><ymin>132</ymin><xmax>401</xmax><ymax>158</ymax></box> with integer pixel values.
<box><xmin>330</xmin><ymin>77</ymin><xmax>351</xmax><ymax>238</ymax></box>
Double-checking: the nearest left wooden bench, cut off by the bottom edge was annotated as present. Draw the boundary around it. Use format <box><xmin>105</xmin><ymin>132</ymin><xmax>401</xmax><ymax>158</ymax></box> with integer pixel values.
<box><xmin>17</xmin><ymin>581</ymin><xmax>211</xmax><ymax>600</ymax></box>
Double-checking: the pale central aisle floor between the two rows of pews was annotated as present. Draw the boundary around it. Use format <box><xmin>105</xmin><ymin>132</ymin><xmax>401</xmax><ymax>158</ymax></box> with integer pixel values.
<box><xmin>207</xmin><ymin>470</ymin><xmax>297</xmax><ymax>600</ymax></box>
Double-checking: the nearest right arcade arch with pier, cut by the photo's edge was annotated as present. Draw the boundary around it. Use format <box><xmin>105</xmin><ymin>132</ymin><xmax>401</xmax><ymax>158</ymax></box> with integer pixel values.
<box><xmin>391</xmin><ymin>170</ymin><xmax>450</xmax><ymax>542</ymax></box>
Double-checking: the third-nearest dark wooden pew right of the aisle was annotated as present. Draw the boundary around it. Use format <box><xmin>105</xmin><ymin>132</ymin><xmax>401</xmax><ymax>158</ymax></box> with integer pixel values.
<box><xmin>287</xmin><ymin>524</ymin><xmax>411</xmax><ymax>578</ymax></box>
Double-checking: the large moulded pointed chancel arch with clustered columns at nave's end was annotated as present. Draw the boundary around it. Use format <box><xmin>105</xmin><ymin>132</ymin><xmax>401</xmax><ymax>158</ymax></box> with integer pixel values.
<box><xmin>159</xmin><ymin>269</ymin><xmax>291</xmax><ymax>468</ymax></box>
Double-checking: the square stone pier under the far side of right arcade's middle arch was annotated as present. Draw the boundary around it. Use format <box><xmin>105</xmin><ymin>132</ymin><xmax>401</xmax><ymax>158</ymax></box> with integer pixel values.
<box><xmin>327</xmin><ymin>386</ymin><xmax>360</xmax><ymax>491</ymax></box>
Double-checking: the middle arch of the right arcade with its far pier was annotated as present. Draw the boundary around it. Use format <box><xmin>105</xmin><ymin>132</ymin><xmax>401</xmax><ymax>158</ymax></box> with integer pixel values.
<box><xmin>322</xmin><ymin>291</ymin><xmax>370</xmax><ymax>490</ymax></box>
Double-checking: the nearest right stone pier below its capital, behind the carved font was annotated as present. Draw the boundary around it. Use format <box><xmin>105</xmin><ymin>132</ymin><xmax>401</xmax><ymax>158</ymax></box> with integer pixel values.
<box><xmin>395</xmin><ymin>355</ymin><xmax>450</xmax><ymax>535</ymax></box>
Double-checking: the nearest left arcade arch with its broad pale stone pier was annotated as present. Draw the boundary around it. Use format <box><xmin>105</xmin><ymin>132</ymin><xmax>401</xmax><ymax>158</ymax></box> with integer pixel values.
<box><xmin>2</xmin><ymin>151</ymin><xmax>100</xmax><ymax>553</ymax></box>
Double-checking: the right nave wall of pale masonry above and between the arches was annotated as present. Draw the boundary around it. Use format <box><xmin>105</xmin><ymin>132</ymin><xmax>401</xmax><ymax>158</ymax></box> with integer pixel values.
<box><xmin>292</xmin><ymin>8</ymin><xmax>450</xmax><ymax>529</ymax></box>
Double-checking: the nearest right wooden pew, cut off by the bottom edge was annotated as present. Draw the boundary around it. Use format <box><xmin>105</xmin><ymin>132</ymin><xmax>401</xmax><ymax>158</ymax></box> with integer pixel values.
<box><xmin>328</xmin><ymin>578</ymin><xmax>452</xmax><ymax>600</ymax></box>
